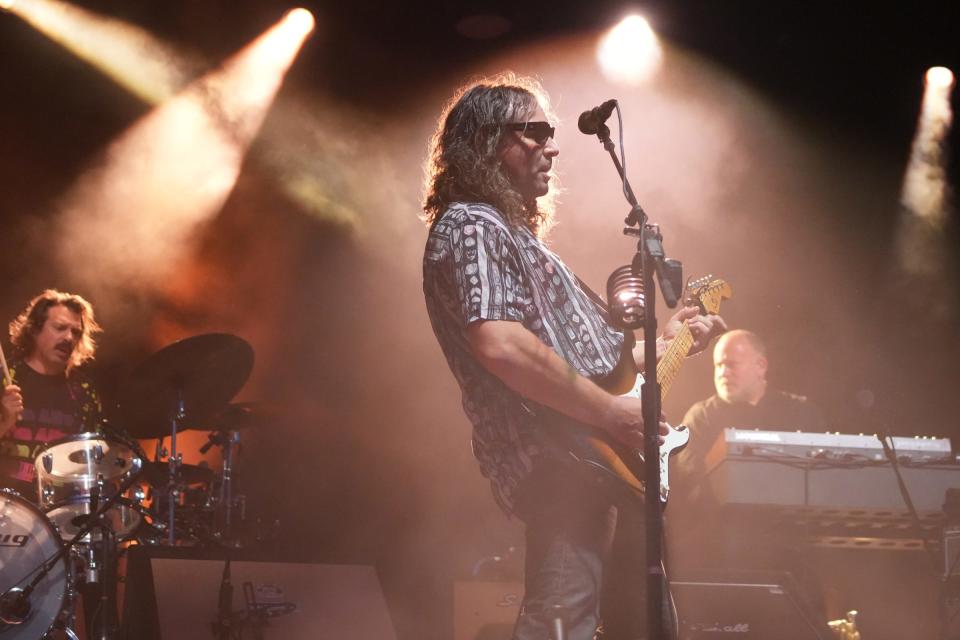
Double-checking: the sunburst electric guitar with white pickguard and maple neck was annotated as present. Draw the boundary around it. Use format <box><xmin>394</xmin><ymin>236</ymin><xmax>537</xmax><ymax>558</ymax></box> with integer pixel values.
<box><xmin>553</xmin><ymin>276</ymin><xmax>732</xmax><ymax>504</ymax></box>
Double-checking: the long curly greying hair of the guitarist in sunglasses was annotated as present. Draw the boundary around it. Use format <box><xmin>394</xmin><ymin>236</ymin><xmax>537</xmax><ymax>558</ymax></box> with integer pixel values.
<box><xmin>423</xmin><ymin>72</ymin><xmax>558</xmax><ymax>237</ymax></box>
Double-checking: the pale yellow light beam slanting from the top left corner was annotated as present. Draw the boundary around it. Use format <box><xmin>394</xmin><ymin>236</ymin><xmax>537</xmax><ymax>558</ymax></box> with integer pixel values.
<box><xmin>0</xmin><ymin>0</ymin><xmax>202</xmax><ymax>104</ymax></box>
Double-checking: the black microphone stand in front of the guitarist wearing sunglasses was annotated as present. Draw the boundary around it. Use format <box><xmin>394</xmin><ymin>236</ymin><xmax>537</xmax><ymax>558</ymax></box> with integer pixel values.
<box><xmin>597</xmin><ymin>121</ymin><xmax>679</xmax><ymax>640</ymax></box>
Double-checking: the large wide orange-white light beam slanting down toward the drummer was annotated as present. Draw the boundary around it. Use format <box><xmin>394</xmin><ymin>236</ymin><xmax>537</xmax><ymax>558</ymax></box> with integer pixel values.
<box><xmin>55</xmin><ymin>10</ymin><xmax>309</xmax><ymax>293</ymax></box>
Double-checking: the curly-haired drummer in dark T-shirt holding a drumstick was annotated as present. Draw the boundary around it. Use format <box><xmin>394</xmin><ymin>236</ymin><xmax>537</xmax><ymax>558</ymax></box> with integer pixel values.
<box><xmin>0</xmin><ymin>289</ymin><xmax>101</xmax><ymax>500</ymax></box>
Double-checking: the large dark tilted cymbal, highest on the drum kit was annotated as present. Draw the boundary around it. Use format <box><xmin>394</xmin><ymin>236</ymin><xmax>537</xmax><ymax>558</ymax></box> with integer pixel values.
<box><xmin>119</xmin><ymin>333</ymin><xmax>253</xmax><ymax>438</ymax></box>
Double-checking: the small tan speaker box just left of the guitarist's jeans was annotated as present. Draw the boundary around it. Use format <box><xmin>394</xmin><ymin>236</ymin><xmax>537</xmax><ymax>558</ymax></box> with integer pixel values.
<box><xmin>453</xmin><ymin>580</ymin><xmax>523</xmax><ymax>640</ymax></box>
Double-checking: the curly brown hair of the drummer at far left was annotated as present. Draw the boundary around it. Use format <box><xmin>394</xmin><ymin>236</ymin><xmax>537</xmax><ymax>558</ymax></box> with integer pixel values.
<box><xmin>10</xmin><ymin>289</ymin><xmax>101</xmax><ymax>370</ymax></box>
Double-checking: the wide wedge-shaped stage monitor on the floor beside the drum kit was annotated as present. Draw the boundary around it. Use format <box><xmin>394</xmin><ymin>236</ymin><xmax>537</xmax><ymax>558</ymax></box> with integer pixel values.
<box><xmin>121</xmin><ymin>547</ymin><xmax>396</xmax><ymax>640</ymax></box>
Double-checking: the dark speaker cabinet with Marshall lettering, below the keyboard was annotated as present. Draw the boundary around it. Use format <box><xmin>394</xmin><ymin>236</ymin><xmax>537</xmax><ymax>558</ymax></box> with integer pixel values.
<box><xmin>670</xmin><ymin>571</ymin><xmax>831</xmax><ymax>640</ymax></box>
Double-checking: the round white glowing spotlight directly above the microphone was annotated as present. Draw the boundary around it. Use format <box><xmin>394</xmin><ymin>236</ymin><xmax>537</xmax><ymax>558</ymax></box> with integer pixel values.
<box><xmin>597</xmin><ymin>15</ymin><xmax>663</xmax><ymax>85</ymax></box>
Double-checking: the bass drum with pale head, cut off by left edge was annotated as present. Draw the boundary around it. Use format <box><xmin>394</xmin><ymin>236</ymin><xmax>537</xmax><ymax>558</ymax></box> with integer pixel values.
<box><xmin>0</xmin><ymin>489</ymin><xmax>72</xmax><ymax>640</ymax></box>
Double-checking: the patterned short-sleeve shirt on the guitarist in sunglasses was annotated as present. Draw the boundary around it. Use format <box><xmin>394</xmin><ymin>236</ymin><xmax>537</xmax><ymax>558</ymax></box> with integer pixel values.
<box><xmin>423</xmin><ymin>203</ymin><xmax>623</xmax><ymax>513</ymax></box>
